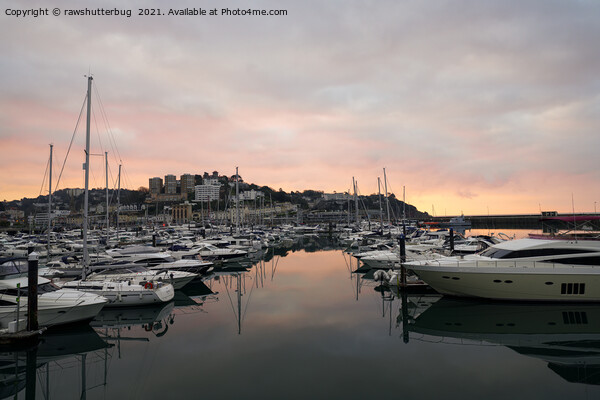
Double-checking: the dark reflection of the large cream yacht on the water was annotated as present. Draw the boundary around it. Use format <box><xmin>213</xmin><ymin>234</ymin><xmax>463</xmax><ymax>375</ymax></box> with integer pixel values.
<box><xmin>406</xmin><ymin>297</ymin><xmax>600</xmax><ymax>385</ymax></box>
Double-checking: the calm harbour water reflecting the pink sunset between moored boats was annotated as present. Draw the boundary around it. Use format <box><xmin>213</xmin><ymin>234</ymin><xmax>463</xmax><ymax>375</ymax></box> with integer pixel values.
<box><xmin>0</xmin><ymin>233</ymin><xmax>600</xmax><ymax>399</ymax></box>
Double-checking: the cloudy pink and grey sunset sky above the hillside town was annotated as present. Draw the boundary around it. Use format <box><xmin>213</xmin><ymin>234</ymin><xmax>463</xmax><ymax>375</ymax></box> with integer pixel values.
<box><xmin>0</xmin><ymin>0</ymin><xmax>600</xmax><ymax>216</ymax></box>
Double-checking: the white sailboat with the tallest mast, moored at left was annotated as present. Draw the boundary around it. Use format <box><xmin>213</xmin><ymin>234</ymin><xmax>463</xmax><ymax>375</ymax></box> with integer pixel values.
<box><xmin>62</xmin><ymin>76</ymin><xmax>175</xmax><ymax>307</ymax></box>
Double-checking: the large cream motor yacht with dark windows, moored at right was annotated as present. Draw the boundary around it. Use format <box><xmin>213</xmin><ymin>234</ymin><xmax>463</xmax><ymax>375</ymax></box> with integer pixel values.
<box><xmin>404</xmin><ymin>239</ymin><xmax>600</xmax><ymax>301</ymax></box>
